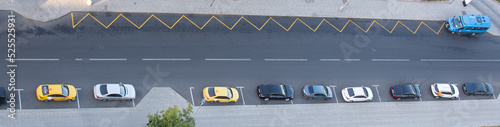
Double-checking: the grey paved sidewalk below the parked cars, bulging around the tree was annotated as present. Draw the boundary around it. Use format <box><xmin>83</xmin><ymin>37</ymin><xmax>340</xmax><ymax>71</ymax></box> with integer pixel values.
<box><xmin>0</xmin><ymin>87</ymin><xmax>500</xmax><ymax>127</ymax></box>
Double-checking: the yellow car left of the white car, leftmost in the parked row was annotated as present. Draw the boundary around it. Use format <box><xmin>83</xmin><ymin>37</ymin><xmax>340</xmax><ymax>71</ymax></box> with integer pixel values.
<box><xmin>36</xmin><ymin>84</ymin><xmax>76</xmax><ymax>102</ymax></box>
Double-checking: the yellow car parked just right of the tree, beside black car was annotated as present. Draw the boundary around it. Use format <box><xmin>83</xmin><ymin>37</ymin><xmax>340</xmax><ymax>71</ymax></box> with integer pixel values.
<box><xmin>203</xmin><ymin>87</ymin><xmax>240</xmax><ymax>103</ymax></box>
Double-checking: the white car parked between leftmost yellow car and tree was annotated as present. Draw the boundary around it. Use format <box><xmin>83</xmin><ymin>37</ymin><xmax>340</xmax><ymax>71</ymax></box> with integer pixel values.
<box><xmin>94</xmin><ymin>83</ymin><xmax>135</xmax><ymax>101</ymax></box>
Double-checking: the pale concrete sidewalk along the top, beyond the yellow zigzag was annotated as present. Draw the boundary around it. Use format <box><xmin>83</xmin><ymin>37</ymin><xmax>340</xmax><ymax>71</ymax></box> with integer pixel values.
<box><xmin>0</xmin><ymin>0</ymin><xmax>500</xmax><ymax>36</ymax></box>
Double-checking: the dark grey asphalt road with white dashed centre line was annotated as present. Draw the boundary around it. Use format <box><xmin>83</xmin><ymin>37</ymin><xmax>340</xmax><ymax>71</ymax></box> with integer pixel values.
<box><xmin>0</xmin><ymin>11</ymin><xmax>500</xmax><ymax>109</ymax></box>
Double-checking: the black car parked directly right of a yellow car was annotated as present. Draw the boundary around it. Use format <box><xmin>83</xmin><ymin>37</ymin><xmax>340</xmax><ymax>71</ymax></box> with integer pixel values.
<box><xmin>257</xmin><ymin>84</ymin><xmax>293</xmax><ymax>101</ymax></box>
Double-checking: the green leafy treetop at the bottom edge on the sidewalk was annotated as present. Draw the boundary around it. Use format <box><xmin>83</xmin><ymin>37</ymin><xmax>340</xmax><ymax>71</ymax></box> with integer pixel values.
<box><xmin>148</xmin><ymin>104</ymin><xmax>195</xmax><ymax>127</ymax></box>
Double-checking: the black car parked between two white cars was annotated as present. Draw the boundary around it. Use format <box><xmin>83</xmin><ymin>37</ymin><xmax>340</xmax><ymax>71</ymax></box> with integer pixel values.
<box><xmin>391</xmin><ymin>84</ymin><xmax>422</xmax><ymax>100</ymax></box>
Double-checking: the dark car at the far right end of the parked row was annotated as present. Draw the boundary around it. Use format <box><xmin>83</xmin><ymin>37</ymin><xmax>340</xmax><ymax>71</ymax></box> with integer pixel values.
<box><xmin>462</xmin><ymin>82</ymin><xmax>493</xmax><ymax>96</ymax></box>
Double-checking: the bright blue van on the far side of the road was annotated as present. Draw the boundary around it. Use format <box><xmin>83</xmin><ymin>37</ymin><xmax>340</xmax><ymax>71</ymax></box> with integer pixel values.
<box><xmin>446</xmin><ymin>15</ymin><xmax>491</xmax><ymax>35</ymax></box>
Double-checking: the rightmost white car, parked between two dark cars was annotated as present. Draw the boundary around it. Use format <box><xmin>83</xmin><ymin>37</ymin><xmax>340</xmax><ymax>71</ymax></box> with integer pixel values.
<box><xmin>431</xmin><ymin>83</ymin><xmax>459</xmax><ymax>99</ymax></box>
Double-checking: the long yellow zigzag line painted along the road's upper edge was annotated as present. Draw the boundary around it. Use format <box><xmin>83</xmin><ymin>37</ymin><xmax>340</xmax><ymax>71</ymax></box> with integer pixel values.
<box><xmin>71</xmin><ymin>13</ymin><xmax>445</xmax><ymax>34</ymax></box>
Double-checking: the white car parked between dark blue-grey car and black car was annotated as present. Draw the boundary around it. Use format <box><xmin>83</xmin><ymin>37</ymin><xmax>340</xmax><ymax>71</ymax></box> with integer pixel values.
<box><xmin>342</xmin><ymin>87</ymin><xmax>373</xmax><ymax>102</ymax></box>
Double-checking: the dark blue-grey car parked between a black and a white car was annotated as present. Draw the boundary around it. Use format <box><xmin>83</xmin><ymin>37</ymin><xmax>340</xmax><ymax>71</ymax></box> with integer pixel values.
<box><xmin>302</xmin><ymin>85</ymin><xmax>333</xmax><ymax>100</ymax></box>
